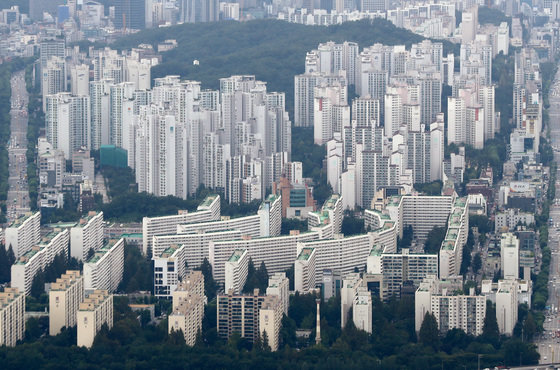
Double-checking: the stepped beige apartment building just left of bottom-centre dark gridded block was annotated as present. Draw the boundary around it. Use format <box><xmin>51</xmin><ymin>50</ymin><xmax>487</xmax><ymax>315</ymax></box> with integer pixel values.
<box><xmin>168</xmin><ymin>294</ymin><xmax>208</xmax><ymax>347</ymax></box>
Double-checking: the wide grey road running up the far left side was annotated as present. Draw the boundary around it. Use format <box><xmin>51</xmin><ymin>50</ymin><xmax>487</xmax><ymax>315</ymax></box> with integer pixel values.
<box><xmin>7</xmin><ymin>71</ymin><xmax>30</xmax><ymax>220</ymax></box>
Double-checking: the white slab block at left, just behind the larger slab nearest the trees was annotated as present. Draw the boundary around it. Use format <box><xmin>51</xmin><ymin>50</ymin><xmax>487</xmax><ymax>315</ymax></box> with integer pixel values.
<box><xmin>70</xmin><ymin>211</ymin><xmax>104</xmax><ymax>261</ymax></box>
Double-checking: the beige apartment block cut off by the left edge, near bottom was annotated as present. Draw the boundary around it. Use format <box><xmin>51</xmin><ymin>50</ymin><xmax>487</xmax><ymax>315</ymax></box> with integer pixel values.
<box><xmin>0</xmin><ymin>288</ymin><xmax>25</xmax><ymax>347</ymax></box>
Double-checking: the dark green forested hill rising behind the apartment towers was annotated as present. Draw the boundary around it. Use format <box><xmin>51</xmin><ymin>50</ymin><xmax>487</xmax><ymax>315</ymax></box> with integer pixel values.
<box><xmin>113</xmin><ymin>19</ymin><xmax>453</xmax><ymax>111</ymax></box>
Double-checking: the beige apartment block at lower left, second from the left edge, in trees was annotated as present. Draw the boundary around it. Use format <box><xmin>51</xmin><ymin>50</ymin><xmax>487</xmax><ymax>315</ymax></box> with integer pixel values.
<box><xmin>49</xmin><ymin>270</ymin><xmax>84</xmax><ymax>336</ymax></box>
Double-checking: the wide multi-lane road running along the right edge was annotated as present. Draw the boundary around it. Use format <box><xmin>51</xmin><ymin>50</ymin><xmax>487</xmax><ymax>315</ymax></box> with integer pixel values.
<box><xmin>535</xmin><ymin>62</ymin><xmax>560</xmax><ymax>364</ymax></box>
